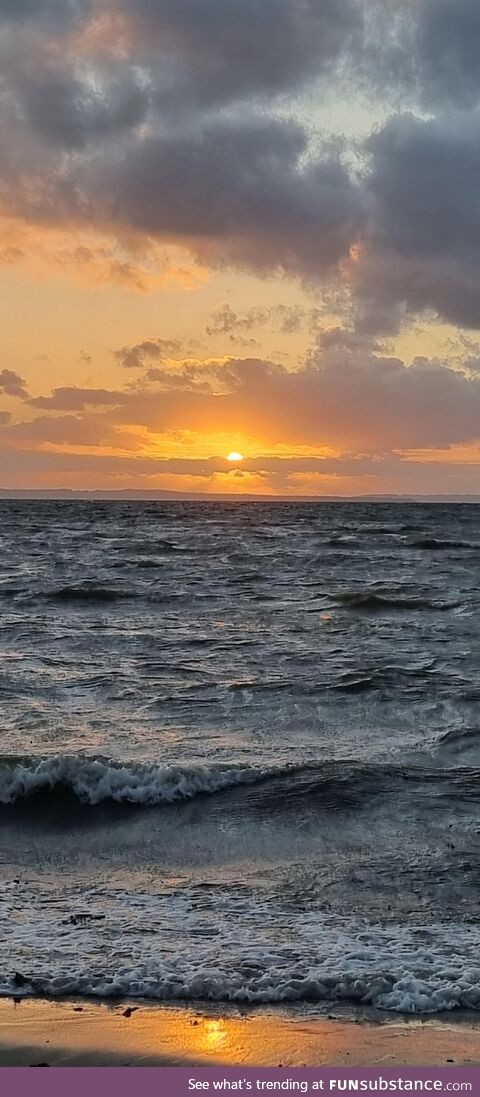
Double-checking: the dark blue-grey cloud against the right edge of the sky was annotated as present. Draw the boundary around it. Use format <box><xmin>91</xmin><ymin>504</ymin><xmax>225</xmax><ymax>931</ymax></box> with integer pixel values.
<box><xmin>351</xmin><ymin>112</ymin><xmax>480</xmax><ymax>332</ymax></box>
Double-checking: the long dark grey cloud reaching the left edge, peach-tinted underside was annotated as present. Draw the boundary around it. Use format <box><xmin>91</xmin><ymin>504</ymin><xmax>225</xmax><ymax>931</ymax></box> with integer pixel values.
<box><xmin>0</xmin><ymin>106</ymin><xmax>366</xmax><ymax>280</ymax></box>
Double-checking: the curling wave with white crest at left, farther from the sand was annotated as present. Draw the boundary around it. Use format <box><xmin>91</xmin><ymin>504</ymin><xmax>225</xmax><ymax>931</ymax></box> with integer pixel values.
<box><xmin>0</xmin><ymin>755</ymin><xmax>480</xmax><ymax>814</ymax></box>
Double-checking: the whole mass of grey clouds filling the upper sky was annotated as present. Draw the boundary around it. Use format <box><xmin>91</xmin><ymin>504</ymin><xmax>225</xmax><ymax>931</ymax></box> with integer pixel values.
<box><xmin>0</xmin><ymin>0</ymin><xmax>480</xmax><ymax>342</ymax></box>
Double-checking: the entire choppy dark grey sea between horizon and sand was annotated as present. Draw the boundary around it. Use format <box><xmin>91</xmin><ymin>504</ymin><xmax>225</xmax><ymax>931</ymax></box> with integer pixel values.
<box><xmin>0</xmin><ymin>500</ymin><xmax>480</xmax><ymax>1013</ymax></box>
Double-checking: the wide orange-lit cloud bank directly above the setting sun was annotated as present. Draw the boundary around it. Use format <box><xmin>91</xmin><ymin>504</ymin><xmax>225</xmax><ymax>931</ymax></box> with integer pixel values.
<box><xmin>5</xmin><ymin>342</ymin><xmax>480</xmax><ymax>455</ymax></box>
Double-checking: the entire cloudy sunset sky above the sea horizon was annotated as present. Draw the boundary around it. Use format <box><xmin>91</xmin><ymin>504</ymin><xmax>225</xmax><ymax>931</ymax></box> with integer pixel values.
<box><xmin>0</xmin><ymin>0</ymin><xmax>480</xmax><ymax>496</ymax></box>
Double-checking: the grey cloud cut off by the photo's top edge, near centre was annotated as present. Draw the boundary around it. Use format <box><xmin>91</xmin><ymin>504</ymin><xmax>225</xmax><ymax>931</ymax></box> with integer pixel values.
<box><xmin>118</xmin><ymin>0</ymin><xmax>362</xmax><ymax>108</ymax></box>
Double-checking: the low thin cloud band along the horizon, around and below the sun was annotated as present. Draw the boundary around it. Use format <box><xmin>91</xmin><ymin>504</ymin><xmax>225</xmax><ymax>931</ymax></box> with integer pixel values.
<box><xmin>0</xmin><ymin>440</ymin><xmax>480</xmax><ymax>496</ymax></box>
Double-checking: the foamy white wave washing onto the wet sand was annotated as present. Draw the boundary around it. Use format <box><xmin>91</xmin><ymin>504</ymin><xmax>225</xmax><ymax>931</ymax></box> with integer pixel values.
<box><xmin>5</xmin><ymin>926</ymin><xmax>480</xmax><ymax>1014</ymax></box>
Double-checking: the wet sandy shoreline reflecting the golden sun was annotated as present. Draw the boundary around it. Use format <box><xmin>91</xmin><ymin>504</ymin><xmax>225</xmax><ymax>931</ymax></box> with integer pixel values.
<box><xmin>0</xmin><ymin>998</ymin><xmax>480</xmax><ymax>1067</ymax></box>
